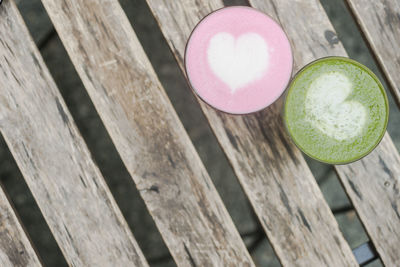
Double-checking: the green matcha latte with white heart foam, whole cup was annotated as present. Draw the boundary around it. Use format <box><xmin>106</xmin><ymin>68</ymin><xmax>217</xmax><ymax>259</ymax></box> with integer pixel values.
<box><xmin>284</xmin><ymin>57</ymin><xmax>389</xmax><ymax>164</ymax></box>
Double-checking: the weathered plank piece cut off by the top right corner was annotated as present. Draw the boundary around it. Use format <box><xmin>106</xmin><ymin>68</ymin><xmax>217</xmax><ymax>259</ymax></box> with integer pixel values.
<box><xmin>347</xmin><ymin>0</ymin><xmax>400</xmax><ymax>107</ymax></box>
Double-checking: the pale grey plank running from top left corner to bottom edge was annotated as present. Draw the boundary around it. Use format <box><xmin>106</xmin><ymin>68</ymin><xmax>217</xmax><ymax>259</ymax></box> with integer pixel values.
<box><xmin>0</xmin><ymin>0</ymin><xmax>148</xmax><ymax>266</ymax></box>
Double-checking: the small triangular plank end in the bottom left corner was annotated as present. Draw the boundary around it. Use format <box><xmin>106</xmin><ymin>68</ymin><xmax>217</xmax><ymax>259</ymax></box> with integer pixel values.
<box><xmin>0</xmin><ymin>186</ymin><xmax>42</xmax><ymax>267</ymax></box>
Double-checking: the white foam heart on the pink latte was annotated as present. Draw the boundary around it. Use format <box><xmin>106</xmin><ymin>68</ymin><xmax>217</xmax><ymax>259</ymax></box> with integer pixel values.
<box><xmin>207</xmin><ymin>32</ymin><xmax>269</xmax><ymax>93</ymax></box>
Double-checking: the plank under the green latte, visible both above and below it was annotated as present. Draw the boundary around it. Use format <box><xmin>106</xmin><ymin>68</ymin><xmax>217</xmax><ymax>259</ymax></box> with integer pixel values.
<box><xmin>250</xmin><ymin>0</ymin><xmax>400</xmax><ymax>266</ymax></box>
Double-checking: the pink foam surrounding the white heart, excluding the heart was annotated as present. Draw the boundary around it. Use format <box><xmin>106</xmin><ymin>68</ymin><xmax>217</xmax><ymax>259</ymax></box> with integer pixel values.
<box><xmin>185</xmin><ymin>7</ymin><xmax>293</xmax><ymax>114</ymax></box>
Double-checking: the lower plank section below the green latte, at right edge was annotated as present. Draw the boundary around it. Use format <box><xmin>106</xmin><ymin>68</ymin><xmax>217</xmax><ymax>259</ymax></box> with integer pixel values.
<box><xmin>336</xmin><ymin>133</ymin><xmax>400</xmax><ymax>266</ymax></box>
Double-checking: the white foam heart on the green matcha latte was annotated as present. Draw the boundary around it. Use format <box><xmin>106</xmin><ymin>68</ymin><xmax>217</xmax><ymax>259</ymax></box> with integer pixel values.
<box><xmin>305</xmin><ymin>72</ymin><xmax>367</xmax><ymax>141</ymax></box>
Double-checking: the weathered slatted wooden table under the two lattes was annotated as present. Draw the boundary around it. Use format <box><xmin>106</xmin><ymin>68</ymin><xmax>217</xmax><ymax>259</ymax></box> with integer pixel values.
<box><xmin>0</xmin><ymin>0</ymin><xmax>400</xmax><ymax>266</ymax></box>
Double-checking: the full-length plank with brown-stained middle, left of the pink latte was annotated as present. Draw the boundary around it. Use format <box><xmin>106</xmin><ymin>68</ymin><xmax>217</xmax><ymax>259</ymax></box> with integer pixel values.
<box><xmin>42</xmin><ymin>0</ymin><xmax>253</xmax><ymax>266</ymax></box>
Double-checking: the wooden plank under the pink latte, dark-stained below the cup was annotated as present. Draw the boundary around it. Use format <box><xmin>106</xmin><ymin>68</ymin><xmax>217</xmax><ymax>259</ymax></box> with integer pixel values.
<box><xmin>147</xmin><ymin>0</ymin><xmax>357</xmax><ymax>266</ymax></box>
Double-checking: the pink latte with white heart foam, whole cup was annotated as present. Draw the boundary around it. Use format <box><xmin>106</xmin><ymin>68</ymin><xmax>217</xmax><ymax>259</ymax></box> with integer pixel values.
<box><xmin>185</xmin><ymin>6</ymin><xmax>293</xmax><ymax>114</ymax></box>
